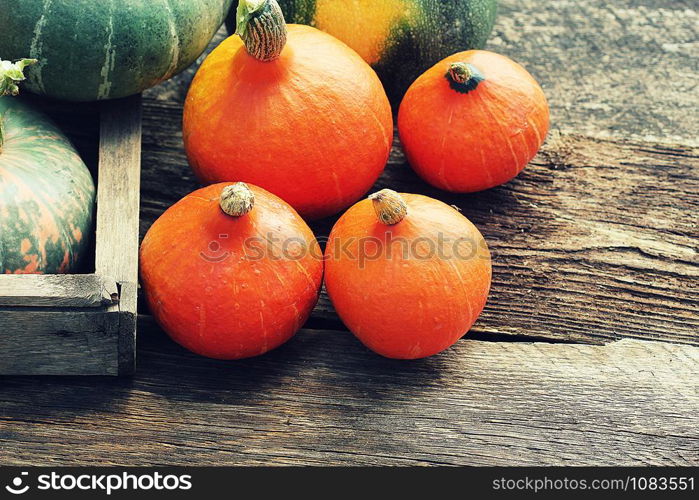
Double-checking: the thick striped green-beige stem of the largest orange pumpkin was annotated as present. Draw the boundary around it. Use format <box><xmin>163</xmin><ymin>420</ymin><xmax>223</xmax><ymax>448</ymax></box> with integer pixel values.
<box><xmin>235</xmin><ymin>0</ymin><xmax>287</xmax><ymax>62</ymax></box>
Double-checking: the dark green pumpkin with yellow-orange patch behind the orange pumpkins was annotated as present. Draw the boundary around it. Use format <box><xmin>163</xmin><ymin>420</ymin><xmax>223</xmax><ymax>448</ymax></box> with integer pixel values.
<box><xmin>228</xmin><ymin>0</ymin><xmax>497</xmax><ymax>104</ymax></box>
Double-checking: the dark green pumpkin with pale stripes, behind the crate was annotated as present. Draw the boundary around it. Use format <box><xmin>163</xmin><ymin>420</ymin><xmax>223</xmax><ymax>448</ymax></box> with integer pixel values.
<box><xmin>0</xmin><ymin>0</ymin><xmax>232</xmax><ymax>101</ymax></box>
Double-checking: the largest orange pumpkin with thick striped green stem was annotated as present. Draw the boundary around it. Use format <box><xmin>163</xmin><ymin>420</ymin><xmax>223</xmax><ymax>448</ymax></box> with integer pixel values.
<box><xmin>184</xmin><ymin>0</ymin><xmax>393</xmax><ymax>218</ymax></box>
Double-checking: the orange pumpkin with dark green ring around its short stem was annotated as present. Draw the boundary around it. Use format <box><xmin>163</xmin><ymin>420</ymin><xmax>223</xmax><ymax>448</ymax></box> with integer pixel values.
<box><xmin>398</xmin><ymin>50</ymin><xmax>549</xmax><ymax>193</ymax></box>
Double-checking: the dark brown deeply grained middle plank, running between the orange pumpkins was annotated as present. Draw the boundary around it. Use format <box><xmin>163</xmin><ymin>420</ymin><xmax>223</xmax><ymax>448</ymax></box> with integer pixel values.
<box><xmin>141</xmin><ymin>92</ymin><xmax>699</xmax><ymax>344</ymax></box>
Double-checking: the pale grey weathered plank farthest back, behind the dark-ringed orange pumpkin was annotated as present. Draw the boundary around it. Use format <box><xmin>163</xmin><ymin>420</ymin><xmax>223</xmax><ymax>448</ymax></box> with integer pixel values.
<box><xmin>487</xmin><ymin>0</ymin><xmax>699</xmax><ymax>147</ymax></box>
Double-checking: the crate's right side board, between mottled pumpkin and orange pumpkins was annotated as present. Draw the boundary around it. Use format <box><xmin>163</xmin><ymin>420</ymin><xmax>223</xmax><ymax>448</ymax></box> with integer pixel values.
<box><xmin>95</xmin><ymin>96</ymin><xmax>141</xmax><ymax>283</ymax></box>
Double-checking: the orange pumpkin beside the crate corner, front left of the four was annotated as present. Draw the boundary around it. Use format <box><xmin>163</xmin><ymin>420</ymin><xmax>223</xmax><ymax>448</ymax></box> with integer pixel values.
<box><xmin>140</xmin><ymin>183</ymin><xmax>323</xmax><ymax>359</ymax></box>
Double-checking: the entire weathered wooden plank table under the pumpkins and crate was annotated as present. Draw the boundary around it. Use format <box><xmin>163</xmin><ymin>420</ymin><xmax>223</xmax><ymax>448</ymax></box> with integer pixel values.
<box><xmin>0</xmin><ymin>0</ymin><xmax>699</xmax><ymax>465</ymax></box>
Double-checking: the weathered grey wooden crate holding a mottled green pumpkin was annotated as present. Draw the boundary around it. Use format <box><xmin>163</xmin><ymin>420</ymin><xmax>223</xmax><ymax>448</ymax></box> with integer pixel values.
<box><xmin>0</xmin><ymin>96</ymin><xmax>141</xmax><ymax>375</ymax></box>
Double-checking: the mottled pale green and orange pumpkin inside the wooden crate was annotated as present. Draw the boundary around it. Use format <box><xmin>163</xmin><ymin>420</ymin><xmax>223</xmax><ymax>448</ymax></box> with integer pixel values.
<box><xmin>0</xmin><ymin>97</ymin><xmax>95</xmax><ymax>274</ymax></box>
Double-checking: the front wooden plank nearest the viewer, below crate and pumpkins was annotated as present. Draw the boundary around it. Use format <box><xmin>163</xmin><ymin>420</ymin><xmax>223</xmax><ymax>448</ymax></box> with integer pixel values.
<box><xmin>0</xmin><ymin>323</ymin><xmax>699</xmax><ymax>465</ymax></box>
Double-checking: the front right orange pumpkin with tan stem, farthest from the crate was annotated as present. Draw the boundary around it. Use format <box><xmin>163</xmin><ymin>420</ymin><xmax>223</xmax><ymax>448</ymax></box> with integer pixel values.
<box><xmin>325</xmin><ymin>190</ymin><xmax>491</xmax><ymax>359</ymax></box>
